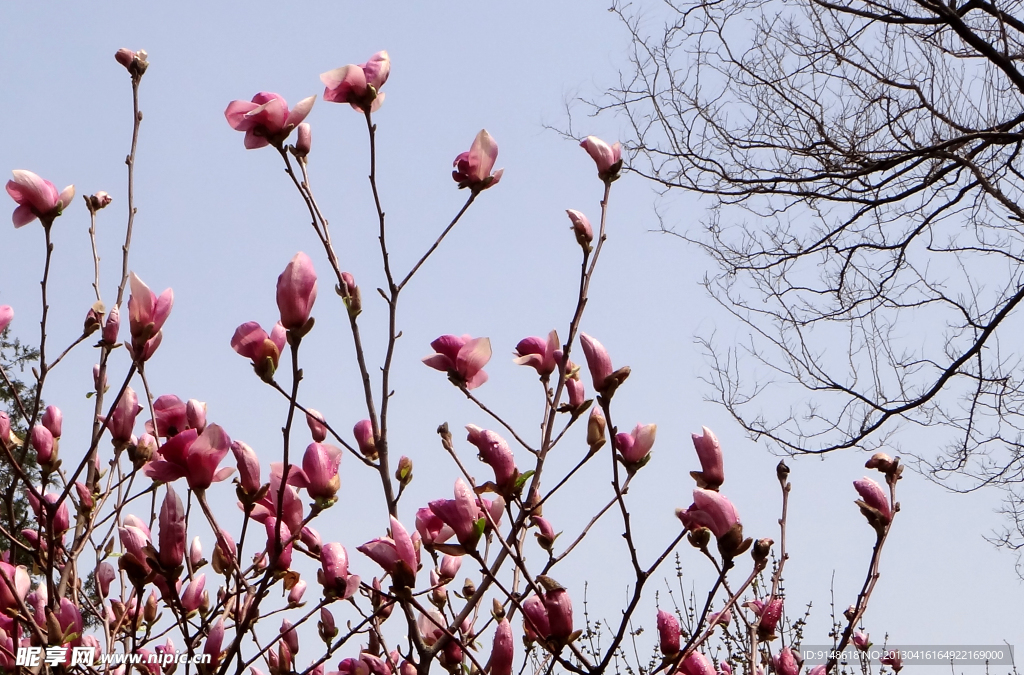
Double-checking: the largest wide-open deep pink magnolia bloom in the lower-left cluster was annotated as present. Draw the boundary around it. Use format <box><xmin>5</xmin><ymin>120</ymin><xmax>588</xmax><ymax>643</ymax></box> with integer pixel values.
<box><xmin>143</xmin><ymin>424</ymin><xmax>234</xmax><ymax>491</ymax></box>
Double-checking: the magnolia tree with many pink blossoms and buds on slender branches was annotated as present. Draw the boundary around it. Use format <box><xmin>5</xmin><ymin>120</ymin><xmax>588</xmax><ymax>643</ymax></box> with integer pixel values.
<box><xmin>0</xmin><ymin>49</ymin><xmax>901</xmax><ymax>675</ymax></box>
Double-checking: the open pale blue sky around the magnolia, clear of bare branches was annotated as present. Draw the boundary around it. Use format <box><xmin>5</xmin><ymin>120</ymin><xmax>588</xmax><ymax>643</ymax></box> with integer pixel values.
<box><xmin>0</xmin><ymin>2</ymin><xmax>1024</xmax><ymax>672</ymax></box>
